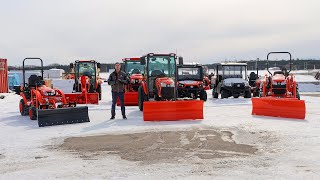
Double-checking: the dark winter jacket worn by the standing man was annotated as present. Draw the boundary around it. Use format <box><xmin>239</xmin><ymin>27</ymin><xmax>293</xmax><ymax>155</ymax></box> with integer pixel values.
<box><xmin>108</xmin><ymin>71</ymin><xmax>128</xmax><ymax>92</ymax></box>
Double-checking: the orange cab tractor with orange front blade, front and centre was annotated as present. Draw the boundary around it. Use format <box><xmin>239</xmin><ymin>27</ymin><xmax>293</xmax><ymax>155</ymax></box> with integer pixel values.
<box><xmin>138</xmin><ymin>53</ymin><xmax>204</xmax><ymax>121</ymax></box>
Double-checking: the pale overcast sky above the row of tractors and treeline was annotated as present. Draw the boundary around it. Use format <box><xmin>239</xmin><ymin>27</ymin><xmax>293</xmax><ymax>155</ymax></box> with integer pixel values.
<box><xmin>0</xmin><ymin>0</ymin><xmax>320</xmax><ymax>65</ymax></box>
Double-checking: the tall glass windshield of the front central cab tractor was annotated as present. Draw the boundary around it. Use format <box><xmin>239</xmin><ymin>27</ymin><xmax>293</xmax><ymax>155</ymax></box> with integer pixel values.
<box><xmin>148</xmin><ymin>56</ymin><xmax>175</xmax><ymax>78</ymax></box>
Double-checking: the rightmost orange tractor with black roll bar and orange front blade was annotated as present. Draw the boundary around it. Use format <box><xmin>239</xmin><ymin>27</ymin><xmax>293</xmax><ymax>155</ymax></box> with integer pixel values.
<box><xmin>252</xmin><ymin>52</ymin><xmax>306</xmax><ymax>119</ymax></box>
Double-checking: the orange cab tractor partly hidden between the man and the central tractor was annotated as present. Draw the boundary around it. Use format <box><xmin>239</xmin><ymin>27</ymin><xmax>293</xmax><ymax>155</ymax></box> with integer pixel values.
<box><xmin>117</xmin><ymin>58</ymin><xmax>144</xmax><ymax>106</ymax></box>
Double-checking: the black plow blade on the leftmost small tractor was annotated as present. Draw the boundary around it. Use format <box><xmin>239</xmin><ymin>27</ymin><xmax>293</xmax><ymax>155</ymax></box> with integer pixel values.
<box><xmin>38</xmin><ymin>106</ymin><xmax>90</xmax><ymax>127</ymax></box>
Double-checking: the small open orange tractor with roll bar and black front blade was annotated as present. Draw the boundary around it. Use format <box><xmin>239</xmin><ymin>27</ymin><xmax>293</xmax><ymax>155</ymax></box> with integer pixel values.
<box><xmin>16</xmin><ymin>58</ymin><xmax>90</xmax><ymax>127</ymax></box>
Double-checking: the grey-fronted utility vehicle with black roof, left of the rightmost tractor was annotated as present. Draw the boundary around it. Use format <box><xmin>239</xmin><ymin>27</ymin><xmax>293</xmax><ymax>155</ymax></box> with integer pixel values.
<box><xmin>211</xmin><ymin>63</ymin><xmax>251</xmax><ymax>99</ymax></box>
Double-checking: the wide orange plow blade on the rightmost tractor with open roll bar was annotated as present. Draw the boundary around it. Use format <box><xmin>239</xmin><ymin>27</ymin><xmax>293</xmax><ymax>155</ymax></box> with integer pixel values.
<box><xmin>251</xmin><ymin>97</ymin><xmax>306</xmax><ymax>119</ymax></box>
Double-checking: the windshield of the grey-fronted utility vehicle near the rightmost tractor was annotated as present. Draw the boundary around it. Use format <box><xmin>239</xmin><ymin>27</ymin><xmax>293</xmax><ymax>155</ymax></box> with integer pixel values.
<box><xmin>222</xmin><ymin>65</ymin><xmax>247</xmax><ymax>79</ymax></box>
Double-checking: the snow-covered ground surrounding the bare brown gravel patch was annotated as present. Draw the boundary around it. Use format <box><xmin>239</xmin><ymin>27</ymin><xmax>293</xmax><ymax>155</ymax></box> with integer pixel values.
<box><xmin>0</xmin><ymin>74</ymin><xmax>320</xmax><ymax>179</ymax></box>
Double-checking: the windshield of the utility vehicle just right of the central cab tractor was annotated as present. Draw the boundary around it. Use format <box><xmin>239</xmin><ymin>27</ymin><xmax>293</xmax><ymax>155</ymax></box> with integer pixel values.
<box><xmin>178</xmin><ymin>67</ymin><xmax>203</xmax><ymax>81</ymax></box>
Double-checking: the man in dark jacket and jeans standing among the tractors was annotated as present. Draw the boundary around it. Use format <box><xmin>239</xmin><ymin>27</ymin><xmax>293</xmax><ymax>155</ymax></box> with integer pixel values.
<box><xmin>108</xmin><ymin>62</ymin><xmax>128</xmax><ymax>119</ymax></box>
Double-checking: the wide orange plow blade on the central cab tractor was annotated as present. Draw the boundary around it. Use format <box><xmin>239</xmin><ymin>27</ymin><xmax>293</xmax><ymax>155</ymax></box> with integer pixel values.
<box><xmin>143</xmin><ymin>100</ymin><xmax>203</xmax><ymax>121</ymax></box>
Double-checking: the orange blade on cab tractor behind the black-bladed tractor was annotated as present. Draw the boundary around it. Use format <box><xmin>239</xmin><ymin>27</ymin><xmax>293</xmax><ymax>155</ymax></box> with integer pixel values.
<box><xmin>65</xmin><ymin>93</ymin><xmax>99</xmax><ymax>104</ymax></box>
